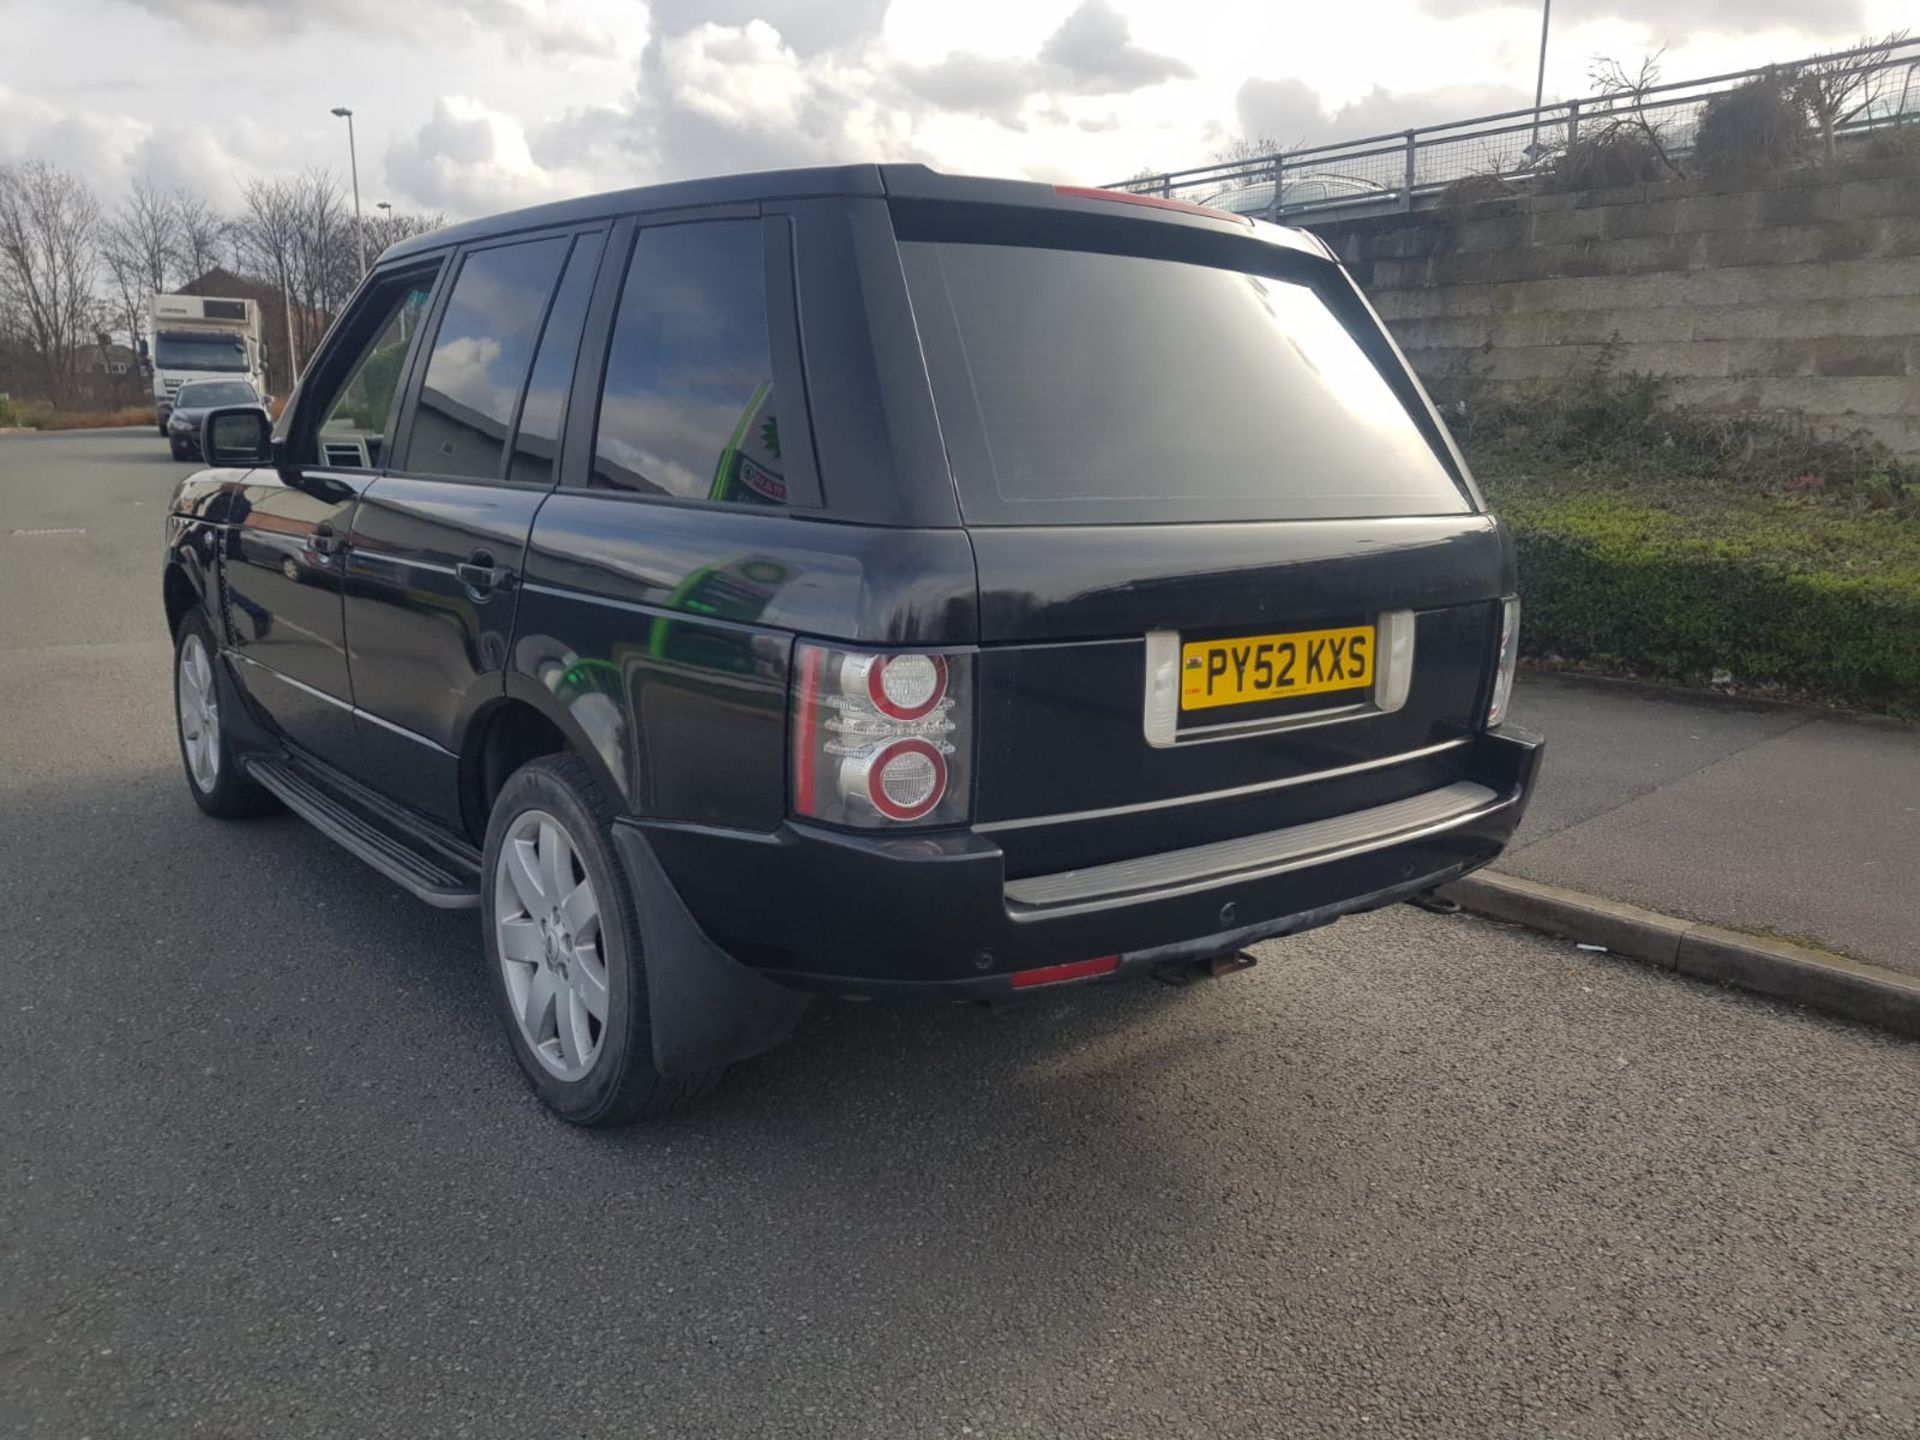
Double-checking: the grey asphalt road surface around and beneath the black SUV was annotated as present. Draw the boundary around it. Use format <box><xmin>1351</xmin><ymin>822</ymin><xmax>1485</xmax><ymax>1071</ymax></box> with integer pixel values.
<box><xmin>11</xmin><ymin>432</ymin><xmax>1920</xmax><ymax>1440</ymax></box>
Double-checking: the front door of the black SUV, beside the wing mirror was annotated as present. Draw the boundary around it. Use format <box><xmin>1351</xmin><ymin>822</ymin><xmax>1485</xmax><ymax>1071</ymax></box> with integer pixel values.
<box><xmin>225</xmin><ymin>265</ymin><xmax>434</xmax><ymax>770</ymax></box>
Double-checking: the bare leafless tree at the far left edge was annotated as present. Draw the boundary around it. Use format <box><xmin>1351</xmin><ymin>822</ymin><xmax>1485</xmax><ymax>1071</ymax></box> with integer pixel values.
<box><xmin>0</xmin><ymin>159</ymin><xmax>100</xmax><ymax>405</ymax></box>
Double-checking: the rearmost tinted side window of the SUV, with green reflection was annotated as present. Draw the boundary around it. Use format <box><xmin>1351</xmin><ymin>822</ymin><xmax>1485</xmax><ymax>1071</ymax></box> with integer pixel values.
<box><xmin>593</xmin><ymin>221</ymin><xmax>787</xmax><ymax>505</ymax></box>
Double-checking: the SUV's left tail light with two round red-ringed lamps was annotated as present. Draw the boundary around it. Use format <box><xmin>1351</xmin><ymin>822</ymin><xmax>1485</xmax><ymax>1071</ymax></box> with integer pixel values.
<box><xmin>793</xmin><ymin>643</ymin><xmax>973</xmax><ymax>828</ymax></box>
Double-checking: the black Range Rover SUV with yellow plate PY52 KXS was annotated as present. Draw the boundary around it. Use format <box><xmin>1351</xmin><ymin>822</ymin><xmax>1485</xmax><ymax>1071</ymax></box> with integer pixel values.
<box><xmin>165</xmin><ymin>165</ymin><xmax>1540</xmax><ymax>1123</ymax></box>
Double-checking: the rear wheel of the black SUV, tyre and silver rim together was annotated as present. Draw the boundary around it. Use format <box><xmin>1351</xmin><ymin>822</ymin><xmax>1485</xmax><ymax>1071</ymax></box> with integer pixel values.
<box><xmin>480</xmin><ymin>755</ymin><xmax>720</xmax><ymax>1125</ymax></box>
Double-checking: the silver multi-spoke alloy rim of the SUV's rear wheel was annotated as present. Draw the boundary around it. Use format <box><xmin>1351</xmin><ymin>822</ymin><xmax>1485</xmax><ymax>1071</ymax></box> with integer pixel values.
<box><xmin>493</xmin><ymin>810</ymin><xmax>607</xmax><ymax>1081</ymax></box>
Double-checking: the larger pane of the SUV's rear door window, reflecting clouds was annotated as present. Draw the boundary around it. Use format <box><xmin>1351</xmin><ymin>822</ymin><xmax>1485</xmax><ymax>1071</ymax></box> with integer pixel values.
<box><xmin>407</xmin><ymin>236</ymin><xmax>566</xmax><ymax>480</ymax></box>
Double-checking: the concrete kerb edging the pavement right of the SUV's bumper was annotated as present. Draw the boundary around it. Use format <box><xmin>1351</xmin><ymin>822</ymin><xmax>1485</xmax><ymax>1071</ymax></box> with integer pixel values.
<box><xmin>1440</xmin><ymin>870</ymin><xmax>1920</xmax><ymax>1037</ymax></box>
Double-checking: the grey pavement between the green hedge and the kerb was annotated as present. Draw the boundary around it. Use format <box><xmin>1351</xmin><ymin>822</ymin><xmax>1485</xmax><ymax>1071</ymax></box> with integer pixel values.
<box><xmin>1498</xmin><ymin>672</ymin><xmax>1920</xmax><ymax>975</ymax></box>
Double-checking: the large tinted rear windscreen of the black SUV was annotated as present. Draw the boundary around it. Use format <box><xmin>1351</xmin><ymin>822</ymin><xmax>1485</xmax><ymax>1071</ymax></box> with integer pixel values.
<box><xmin>900</xmin><ymin>240</ymin><xmax>1471</xmax><ymax>524</ymax></box>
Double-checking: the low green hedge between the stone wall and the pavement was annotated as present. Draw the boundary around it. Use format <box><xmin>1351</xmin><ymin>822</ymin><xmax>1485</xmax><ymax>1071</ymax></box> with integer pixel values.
<box><xmin>1496</xmin><ymin>495</ymin><xmax>1920</xmax><ymax>714</ymax></box>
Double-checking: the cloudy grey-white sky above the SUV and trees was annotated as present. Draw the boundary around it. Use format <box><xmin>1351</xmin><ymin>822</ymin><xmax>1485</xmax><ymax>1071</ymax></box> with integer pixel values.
<box><xmin>0</xmin><ymin>0</ymin><xmax>1910</xmax><ymax>215</ymax></box>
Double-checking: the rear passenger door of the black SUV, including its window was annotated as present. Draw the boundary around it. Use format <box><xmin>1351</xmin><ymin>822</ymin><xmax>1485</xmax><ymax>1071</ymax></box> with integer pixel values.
<box><xmin>346</xmin><ymin>230</ymin><xmax>603</xmax><ymax>824</ymax></box>
